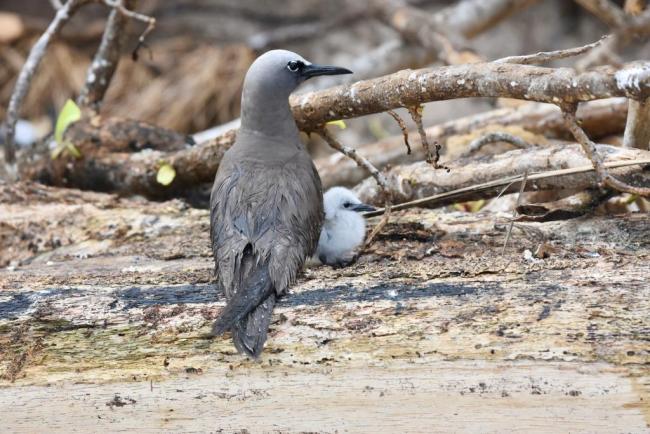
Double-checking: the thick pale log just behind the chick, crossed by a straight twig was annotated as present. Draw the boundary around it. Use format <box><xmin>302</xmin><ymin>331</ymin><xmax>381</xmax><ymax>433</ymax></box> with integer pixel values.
<box><xmin>355</xmin><ymin>144</ymin><xmax>650</xmax><ymax>206</ymax></box>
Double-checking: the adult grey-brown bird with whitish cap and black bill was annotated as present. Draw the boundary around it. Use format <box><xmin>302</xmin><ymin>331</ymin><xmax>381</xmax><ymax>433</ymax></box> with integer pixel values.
<box><xmin>210</xmin><ymin>50</ymin><xmax>351</xmax><ymax>358</ymax></box>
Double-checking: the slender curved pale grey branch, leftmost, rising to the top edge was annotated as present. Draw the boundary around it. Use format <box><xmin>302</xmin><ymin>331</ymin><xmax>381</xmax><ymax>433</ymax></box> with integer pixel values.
<box><xmin>5</xmin><ymin>0</ymin><xmax>87</xmax><ymax>164</ymax></box>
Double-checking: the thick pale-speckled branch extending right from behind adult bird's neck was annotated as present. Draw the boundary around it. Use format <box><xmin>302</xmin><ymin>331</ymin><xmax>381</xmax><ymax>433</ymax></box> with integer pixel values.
<box><xmin>291</xmin><ymin>62</ymin><xmax>650</xmax><ymax>131</ymax></box>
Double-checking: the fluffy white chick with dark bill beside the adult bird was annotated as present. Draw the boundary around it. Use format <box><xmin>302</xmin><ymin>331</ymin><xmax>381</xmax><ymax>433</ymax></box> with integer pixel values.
<box><xmin>315</xmin><ymin>187</ymin><xmax>375</xmax><ymax>266</ymax></box>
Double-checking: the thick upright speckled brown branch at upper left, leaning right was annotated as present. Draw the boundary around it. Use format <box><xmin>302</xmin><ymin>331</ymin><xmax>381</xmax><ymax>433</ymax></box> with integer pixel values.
<box><xmin>77</xmin><ymin>0</ymin><xmax>136</xmax><ymax>113</ymax></box>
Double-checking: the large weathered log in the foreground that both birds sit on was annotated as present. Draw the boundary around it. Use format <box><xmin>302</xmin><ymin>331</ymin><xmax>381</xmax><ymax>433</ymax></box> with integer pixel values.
<box><xmin>0</xmin><ymin>181</ymin><xmax>650</xmax><ymax>433</ymax></box>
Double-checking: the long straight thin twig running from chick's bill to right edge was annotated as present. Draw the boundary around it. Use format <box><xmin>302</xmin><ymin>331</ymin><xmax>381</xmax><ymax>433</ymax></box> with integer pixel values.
<box><xmin>364</xmin><ymin>158</ymin><xmax>650</xmax><ymax>217</ymax></box>
